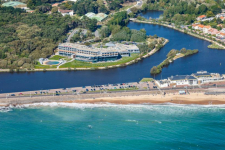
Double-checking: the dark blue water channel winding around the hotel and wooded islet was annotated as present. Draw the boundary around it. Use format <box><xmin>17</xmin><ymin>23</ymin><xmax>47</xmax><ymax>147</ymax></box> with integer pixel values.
<box><xmin>0</xmin><ymin>11</ymin><xmax>225</xmax><ymax>93</ymax></box>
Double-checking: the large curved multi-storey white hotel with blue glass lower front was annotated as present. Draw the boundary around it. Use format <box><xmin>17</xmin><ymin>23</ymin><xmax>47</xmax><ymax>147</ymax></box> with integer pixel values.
<box><xmin>58</xmin><ymin>43</ymin><xmax>140</xmax><ymax>62</ymax></box>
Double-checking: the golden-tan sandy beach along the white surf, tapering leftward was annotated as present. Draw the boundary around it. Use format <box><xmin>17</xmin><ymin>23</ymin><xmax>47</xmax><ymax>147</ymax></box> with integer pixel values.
<box><xmin>65</xmin><ymin>93</ymin><xmax>225</xmax><ymax>105</ymax></box>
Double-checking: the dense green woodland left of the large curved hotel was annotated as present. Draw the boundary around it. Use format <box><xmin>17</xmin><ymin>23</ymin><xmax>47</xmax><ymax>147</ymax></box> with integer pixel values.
<box><xmin>0</xmin><ymin>7</ymin><xmax>81</xmax><ymax>68</ymax></box>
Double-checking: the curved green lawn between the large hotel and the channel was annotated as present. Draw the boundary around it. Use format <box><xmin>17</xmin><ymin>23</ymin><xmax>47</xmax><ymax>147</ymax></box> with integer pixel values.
<box><xmin>60</xmin><ymin>54</ymin><xmax>139</xmax><ymax>68</ymax></box>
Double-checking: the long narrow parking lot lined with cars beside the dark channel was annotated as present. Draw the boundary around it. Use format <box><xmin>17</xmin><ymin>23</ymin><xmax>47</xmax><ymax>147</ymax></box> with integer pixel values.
<box><xmin>0</xmin><ymin>82</ymin><xmax>156</xmax><ymax>98</ymax></box>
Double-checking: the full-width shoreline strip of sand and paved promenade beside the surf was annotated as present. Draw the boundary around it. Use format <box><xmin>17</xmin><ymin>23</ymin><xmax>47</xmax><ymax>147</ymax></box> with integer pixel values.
<box><xmin>0</xmin><ymin>90</ymin><xmax>225</xmax><ymax>107</ymax></box>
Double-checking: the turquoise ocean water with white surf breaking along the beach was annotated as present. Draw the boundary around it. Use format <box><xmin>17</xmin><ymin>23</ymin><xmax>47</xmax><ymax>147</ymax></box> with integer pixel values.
<box><xmin>0</xmin><ymin>103</ymin><xmax>225</xmax><ymax>150</ymax></box>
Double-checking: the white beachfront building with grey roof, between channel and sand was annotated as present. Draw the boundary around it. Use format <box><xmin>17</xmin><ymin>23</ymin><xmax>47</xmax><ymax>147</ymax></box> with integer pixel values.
<box><xmin>168</xmin><ymin>75</ymin><xmax>198</xmax><ymax>86</ymax></box>
